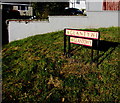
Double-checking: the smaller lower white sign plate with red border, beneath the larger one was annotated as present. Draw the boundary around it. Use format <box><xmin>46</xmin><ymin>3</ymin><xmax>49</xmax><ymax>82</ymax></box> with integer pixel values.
<box><xmin>70</xmin><ymin>37</ymin><xmax>92</xmax><ymax>47</ymax></box>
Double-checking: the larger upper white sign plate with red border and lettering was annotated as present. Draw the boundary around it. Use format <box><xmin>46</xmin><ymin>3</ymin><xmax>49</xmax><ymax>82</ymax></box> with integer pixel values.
<box><xmin>65</xmin><ymin>29</ymin><xmax>99</xmax><ymax>39</ymax></box>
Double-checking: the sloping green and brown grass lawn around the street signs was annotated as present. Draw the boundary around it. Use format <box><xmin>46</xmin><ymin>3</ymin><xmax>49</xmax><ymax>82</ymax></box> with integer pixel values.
<box><xmin>2</xmin><ymin>27</ymin><xmax>120</xmax><ymax>103</ymax></box>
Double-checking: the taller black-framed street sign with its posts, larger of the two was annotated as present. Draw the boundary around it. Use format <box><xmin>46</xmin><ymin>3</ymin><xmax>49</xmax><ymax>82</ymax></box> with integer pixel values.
<box><xmin>64</xmin><ymin>28</ymin><xmax>100</xmax><ymax>67</ymax></box>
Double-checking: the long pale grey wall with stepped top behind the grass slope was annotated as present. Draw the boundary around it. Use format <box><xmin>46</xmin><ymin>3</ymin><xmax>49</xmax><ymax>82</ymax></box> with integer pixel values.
<box><xmin>8</xmin><ymin>11</ymin><xmax>119</xmax><ymax>42</ymax></box>
